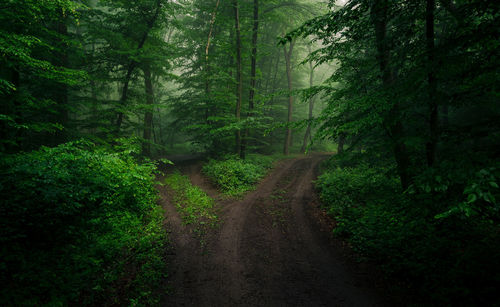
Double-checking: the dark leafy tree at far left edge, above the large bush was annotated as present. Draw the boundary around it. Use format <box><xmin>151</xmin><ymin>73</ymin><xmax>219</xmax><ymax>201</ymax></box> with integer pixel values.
<box><xmin>0</xmin><ymin>0</ymin><xmax>85</xmax><ymax>152</ymax></box>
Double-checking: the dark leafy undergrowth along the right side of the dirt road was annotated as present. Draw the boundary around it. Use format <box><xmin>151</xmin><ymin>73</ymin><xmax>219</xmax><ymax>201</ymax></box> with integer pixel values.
<box><xmin>316</xmin><ymin>161</ymin><xmax>500</xmax><ymax>305</ymax></box>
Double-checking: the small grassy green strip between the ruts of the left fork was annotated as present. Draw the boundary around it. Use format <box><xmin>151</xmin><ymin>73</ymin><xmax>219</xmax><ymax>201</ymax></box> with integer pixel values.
<box><xmin>165</xmin><ymin>173</ymin><xmax>219</xmax><ymax>228</ymax></box>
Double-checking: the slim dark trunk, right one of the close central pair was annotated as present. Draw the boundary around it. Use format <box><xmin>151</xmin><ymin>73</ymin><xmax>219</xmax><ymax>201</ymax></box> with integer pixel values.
<box><xmin>241</xmin><ymin>0</ymin><xmax>259</xmax><ymax>159</ymax></box>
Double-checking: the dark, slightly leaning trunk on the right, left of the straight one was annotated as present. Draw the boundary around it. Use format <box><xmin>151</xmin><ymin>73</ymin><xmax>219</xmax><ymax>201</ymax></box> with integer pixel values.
<box><xmin>370</xmin><ymin>0</ymin><xmax>410</xmax><ymax>190</ymax></box>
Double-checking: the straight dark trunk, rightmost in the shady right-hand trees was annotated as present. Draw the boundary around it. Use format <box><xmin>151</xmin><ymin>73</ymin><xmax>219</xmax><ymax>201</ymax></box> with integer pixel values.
<box><xmin>425</xmin><ymin>0</ymin><xmax>439</xmax><ymax>166</ymax></box>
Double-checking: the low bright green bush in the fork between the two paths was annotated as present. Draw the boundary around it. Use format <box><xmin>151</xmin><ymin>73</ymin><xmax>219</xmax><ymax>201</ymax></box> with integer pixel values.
<box><xmin>203</xmin><ymin>155</ymin><xmax>273</xmax><ymax>196</ymax></box>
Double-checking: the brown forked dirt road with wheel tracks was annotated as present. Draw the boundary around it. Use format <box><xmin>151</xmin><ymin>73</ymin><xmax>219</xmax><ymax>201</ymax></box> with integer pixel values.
<box><xmin>159</xmin><ymin>154</ymin><xmax>387</xmax><ymax>306</ymax></box>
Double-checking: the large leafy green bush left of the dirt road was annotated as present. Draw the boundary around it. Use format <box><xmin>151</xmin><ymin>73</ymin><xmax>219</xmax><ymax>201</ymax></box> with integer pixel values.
<box><xmin>0</xmin><ymin>142</ymin><xmax>166</xmax><ymax>306</ymax></box>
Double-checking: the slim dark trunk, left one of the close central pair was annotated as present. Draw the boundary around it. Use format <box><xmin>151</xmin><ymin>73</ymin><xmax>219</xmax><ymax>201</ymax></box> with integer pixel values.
<box><xmin>233</xmin><ymin>0</ymin><xmax>243</xmax><ymax>157</ymax></box>
